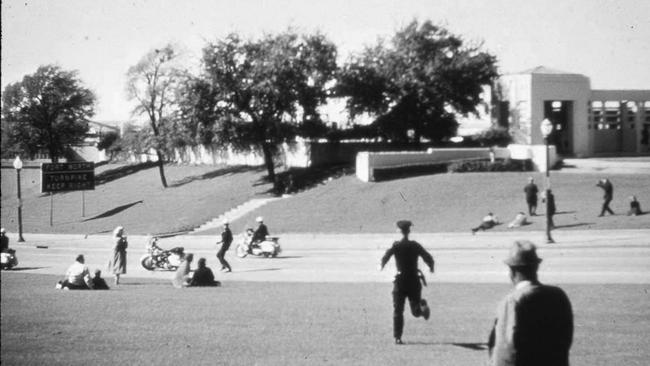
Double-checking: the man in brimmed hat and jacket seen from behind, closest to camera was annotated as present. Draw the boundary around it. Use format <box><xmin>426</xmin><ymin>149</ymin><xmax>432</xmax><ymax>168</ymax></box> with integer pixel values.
<box><xmin>488</xmin><ymin>240</ymin><xmax>573</xmax><ymax>366</ymax></box>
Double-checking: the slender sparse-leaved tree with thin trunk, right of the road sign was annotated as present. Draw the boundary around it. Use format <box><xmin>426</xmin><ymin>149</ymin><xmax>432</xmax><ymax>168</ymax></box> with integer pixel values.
<box><xmin>127</xmin><ymin>45</ymin><xmax>184</xmax><ymax>188</ymax></box>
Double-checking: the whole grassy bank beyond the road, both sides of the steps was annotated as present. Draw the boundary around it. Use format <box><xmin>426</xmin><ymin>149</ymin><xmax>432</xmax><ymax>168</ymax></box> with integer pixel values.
<box><xmin>2</xmin><ymin>165</ymin><xmax>650</xmax><ymax>235</ymax></box>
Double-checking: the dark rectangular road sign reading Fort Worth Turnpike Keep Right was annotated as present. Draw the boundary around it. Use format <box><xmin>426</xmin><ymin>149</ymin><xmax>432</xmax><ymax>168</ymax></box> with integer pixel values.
<box><xmin>41</xmin><ymin>162</ymin><xmax>95</xmax><ymax>192</ymax></box>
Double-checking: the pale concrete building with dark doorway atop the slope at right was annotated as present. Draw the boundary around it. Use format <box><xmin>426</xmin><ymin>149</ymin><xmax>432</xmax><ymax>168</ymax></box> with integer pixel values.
<box><xmin>497</xmin><ymin>66</ymin><xmax>650</xmax><ymax>157</ymax></box>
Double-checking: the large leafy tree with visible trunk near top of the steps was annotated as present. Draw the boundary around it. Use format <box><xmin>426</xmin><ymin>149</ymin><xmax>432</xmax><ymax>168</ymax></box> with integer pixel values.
<box><xmin>193</xmin><ymin>30</ymin><xmax>337</xmax><ymax>188</ymax></box>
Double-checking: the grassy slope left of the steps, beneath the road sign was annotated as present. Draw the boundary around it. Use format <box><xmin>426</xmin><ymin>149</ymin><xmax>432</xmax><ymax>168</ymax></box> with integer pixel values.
<box><xmin>2</xmin><ymin>165</ymin><xmax>271</xmax><ymax>234</ymax></box>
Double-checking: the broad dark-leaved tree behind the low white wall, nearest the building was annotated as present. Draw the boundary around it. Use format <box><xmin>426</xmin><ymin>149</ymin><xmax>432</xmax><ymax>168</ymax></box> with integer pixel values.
<box><xmin>337</xmin><ymin>21</ymin><xmax>498</xmax><ymax>143</ymax></box>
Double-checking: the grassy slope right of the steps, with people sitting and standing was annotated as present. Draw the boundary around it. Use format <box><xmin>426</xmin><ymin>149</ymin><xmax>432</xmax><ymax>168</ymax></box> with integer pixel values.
<box><xmin>234</xmin><ymin>171</ymin><xmax>650</xmax><ymax>235</ymax></box>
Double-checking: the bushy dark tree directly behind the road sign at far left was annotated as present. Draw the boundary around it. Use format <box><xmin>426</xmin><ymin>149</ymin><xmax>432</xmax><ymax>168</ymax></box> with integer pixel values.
<box><xmin>2</xmin><ymin>65</ymin><xmax>95</xmax><ymax>162</ymax></box>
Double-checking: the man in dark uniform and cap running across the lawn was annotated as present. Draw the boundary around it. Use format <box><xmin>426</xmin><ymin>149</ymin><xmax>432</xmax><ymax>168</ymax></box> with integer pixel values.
<box><xmin>379</xmin><ymin>220</ymin><xmax>434</xmax><ymax>344</ymax></box>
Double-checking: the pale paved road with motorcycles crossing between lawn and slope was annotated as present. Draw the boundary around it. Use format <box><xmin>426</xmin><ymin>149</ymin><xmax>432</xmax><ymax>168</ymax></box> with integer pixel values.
<box><xmin>10</xmin><ymin>230</ymin><xmax>650</xmax><ymax>284</ymax></box>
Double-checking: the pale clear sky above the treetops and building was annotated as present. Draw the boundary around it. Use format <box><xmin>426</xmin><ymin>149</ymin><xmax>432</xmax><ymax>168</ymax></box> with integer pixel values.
<box><xmin>1</xmin><ymin>0</ymin><xmax>650</xmax><ymax>122</ymax></box>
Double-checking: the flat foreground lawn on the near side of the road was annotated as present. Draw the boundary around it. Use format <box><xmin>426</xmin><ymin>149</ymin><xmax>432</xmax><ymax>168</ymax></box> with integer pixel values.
<box><xmin>1</xmin><ymin>272</ymin><xmax>650</xmax><ymax>366</ymax></box>
